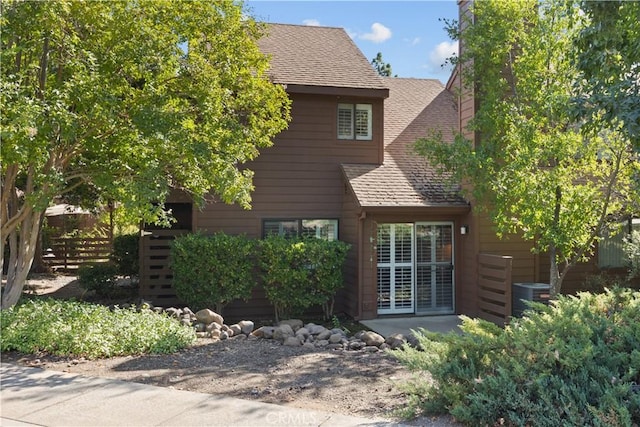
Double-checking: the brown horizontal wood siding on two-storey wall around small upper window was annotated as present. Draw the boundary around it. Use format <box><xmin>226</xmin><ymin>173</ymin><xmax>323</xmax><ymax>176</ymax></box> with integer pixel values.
<box><xmin>196</xmin><ymin>94</ymin><xmax>383</xmax><ymax>237</ymax></box>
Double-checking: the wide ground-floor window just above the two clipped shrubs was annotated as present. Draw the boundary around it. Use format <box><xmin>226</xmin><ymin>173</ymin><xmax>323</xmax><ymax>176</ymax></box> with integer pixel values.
<box><xmin>262</xmin><ymin>219</ymin><xmax>338</xmax><ymax>241</ymax></box>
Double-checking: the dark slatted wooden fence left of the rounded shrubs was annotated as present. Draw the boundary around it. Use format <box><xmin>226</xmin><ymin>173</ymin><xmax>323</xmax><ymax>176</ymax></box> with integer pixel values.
<box><xmin>140</xmin><ymin>230</ymin><xmax>189</xmax><ymax>306</ymax></box>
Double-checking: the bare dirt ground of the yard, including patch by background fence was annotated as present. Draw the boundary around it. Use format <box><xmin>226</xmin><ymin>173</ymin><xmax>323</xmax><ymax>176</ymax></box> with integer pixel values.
<box><xmin>2</xmin><ymin>276</ymin><xmax>457</xmax><ymax>426</ymax></box>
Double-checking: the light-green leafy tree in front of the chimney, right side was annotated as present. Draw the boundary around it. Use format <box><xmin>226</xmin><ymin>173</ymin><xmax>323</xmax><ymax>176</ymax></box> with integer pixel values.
<box><xmin>417</xmin><ymin>0</ymin><xmax>640</xmax><ymax>295</ymax></box>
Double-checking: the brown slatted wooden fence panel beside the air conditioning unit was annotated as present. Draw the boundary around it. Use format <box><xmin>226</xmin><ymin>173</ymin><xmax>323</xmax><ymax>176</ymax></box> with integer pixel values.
<box><xmin>478</xmin><ymin>254</ymin><xmax>513</xmax><ymax>326</ymax></box>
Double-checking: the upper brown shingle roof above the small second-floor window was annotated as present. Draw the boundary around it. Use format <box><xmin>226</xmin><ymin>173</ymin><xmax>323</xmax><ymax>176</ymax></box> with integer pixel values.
<box><xmin>258</xmin><ymin>24</ymin><xmax>386</xmax><ymax>89</ymax></box>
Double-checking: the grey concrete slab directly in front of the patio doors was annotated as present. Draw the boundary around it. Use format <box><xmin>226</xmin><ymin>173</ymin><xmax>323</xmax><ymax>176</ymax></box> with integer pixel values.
<box><xmin>360</xmin><ymin>315</ymin><xmax>462</xmax><ymax>338</ymax></box>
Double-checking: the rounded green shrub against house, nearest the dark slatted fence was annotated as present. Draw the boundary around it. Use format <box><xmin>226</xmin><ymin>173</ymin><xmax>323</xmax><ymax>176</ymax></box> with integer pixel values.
<box><xmin>170</xmin><ymin>233</ymin><xmax>256</xmax><ymax>313</ymax></box>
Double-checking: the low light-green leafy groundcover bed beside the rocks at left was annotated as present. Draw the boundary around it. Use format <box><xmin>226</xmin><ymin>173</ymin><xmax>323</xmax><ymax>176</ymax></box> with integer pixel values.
<box><xmin>0</xmin><ymin>299</ymin><xmax>195</xmax><ymax>359</ymax></box>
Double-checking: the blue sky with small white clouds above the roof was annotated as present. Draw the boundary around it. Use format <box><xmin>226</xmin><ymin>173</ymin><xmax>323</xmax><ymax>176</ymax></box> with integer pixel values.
<box><xmin>245</xmin><ymin>0</ymin><xmax>458</xmax><ymax>83</ymax></box>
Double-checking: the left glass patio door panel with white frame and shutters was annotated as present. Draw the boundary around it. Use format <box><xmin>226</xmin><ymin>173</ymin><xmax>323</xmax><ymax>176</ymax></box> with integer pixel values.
<box><xmin>377</xmin><ymin>224</ymin><xmax>414</xmax><ymax>314</ymax></box>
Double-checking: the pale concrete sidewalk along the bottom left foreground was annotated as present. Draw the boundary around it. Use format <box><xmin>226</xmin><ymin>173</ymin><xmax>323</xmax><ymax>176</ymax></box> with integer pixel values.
<box><xmin>0</xmin><ymin>363</ymin><xmax>460</xmax><ymax>427</ymax></box>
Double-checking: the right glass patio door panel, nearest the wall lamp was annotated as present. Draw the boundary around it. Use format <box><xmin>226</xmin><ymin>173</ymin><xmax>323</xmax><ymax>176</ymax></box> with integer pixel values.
<box><xmin>415</xmin><ymin>223</ymin><xmax>454</xmax><ymax>314</ymax></box>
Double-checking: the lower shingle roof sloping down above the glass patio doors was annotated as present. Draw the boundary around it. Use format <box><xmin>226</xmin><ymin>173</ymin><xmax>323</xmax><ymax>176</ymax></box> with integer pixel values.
<box><xmin>342</xmin><ymin>77</ymin><xmax>468</xmax><ymax>207</ymax></box>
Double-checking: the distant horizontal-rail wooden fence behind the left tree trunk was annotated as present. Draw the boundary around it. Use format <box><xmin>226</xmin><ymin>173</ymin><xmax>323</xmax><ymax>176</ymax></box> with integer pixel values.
<box><xmin>43</xmin><ymin>237</ymin><xmax>113</xmax><ymax>270</ymax></box>
